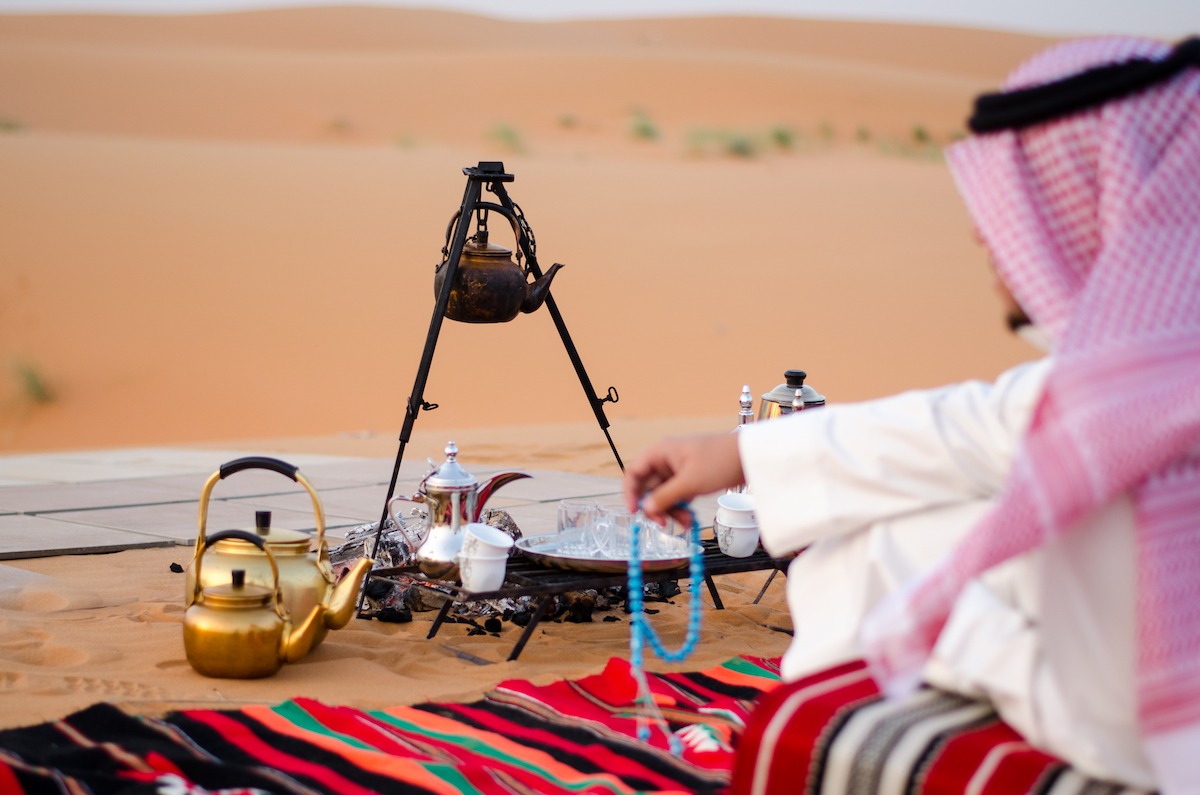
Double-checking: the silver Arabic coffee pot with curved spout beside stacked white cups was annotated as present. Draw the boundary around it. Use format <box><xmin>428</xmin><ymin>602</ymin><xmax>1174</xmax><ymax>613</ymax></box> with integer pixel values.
<box><xmin>388</xmin><ymin>442</ymin><xmax>529</xmax><ymax>580</ymax></box>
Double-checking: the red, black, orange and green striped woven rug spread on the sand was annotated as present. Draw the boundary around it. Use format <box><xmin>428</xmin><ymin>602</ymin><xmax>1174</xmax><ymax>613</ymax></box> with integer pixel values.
<box><xmin>0</xmin><ymin>657</ymin><xmax>779</xmax><ymax>795</ymax></box>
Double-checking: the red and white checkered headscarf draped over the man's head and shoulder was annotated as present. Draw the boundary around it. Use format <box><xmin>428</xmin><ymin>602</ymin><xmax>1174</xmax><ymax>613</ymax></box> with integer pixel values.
<box><xmin>864</xmin><ymin>38</ymin><xmax>1200</xmax><ymax>773</ymax></box>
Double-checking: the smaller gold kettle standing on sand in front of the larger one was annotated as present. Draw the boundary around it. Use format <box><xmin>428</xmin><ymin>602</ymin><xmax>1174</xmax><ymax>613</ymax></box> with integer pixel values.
<box><xmin>184</xmin><ymin>530</ymin><xmax>320</xmax><ymax>679</ymax></box>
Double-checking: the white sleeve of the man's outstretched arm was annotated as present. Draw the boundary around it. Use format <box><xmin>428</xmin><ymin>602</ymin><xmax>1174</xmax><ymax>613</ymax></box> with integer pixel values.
<box><xmin>738</xmin><ymin>359</ymin><xmax>1049</xmax><ymax>555</ymax></box>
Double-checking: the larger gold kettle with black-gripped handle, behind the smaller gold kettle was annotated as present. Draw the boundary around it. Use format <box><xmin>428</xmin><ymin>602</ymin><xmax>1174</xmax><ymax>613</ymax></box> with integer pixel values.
<box><xmin>186</xmin><ymin>456</ymin><xmax>374</xmax><ymax>647</ymax></box>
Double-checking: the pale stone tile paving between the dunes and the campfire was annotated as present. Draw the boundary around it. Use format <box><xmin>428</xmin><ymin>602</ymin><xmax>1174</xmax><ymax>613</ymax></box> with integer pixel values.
<box><xmin>0</xmin><ymin>448</ymin><xmax>716</xmax><ymax>576</ymax></box>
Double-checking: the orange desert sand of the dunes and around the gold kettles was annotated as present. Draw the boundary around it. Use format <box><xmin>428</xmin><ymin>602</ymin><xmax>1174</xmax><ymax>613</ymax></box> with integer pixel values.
<box><xmin>0</xmin><ymin>8</ymin><xmax>1050</xmax><ymax>725</ymax></box>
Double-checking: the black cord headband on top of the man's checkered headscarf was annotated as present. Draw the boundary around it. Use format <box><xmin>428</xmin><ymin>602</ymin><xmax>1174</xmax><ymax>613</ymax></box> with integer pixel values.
<box><xmin>967</xmin><ymin>36</ymin><xmax>1200</xmax><ymax>133</ymax></box>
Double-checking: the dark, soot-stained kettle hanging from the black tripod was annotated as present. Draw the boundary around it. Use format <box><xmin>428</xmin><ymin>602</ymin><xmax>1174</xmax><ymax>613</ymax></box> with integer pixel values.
<box><xmin>433</xmin><ymin>210</ymin><xmax>563</xmax><ymax>323</ymax></box>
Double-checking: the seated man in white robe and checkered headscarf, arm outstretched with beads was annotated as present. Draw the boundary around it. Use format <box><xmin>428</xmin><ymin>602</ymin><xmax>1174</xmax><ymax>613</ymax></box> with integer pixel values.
<box><xmin>625</xmin><ymin>38</ymin><xmax>1200</xmax><ymax>795</ymax></box>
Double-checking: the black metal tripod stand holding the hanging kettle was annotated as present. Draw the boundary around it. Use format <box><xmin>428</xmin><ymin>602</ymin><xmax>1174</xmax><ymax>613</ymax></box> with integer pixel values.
<box><xmin>359</xmin><ymin>161</ymin><xmax>625</xmax><ymax>614</ymax></box>
